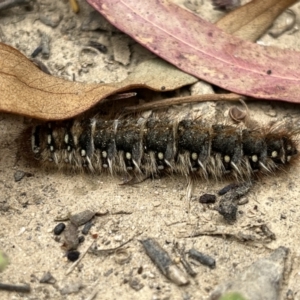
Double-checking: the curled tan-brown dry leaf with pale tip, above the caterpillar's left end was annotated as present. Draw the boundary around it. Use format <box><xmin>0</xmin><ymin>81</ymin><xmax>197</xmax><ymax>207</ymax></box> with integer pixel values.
<box><xmin>0</xmin><ymin>43</ymin><xmax>197</xmax><ymax>120</ymax></box>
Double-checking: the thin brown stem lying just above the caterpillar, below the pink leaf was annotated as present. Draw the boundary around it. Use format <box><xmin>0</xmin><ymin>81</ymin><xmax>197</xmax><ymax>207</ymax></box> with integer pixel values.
<box><xmin>124</xmin><ymin>93</ymin><xmax>244</xmax><ymax>112</ymax></box>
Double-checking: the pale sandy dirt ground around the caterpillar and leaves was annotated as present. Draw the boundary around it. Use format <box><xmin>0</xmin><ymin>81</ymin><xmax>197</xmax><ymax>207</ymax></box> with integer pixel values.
<box><xmin>0</xmin><ymin>0</ymin><xmax>300</xmax><ymax>300</ymax></box>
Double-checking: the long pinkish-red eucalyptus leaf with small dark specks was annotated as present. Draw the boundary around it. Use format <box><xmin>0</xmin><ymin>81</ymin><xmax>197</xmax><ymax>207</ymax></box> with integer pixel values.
<box><xmin>87</xmin><ymin>0</ymin><xmax>300</xmax><ymax>102</ymax></box>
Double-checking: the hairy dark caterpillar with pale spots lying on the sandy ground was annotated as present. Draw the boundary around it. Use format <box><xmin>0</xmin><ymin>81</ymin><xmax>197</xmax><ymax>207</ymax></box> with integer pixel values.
<box><xmin>23</xmin><ymin>117</ymin><xmax>298</xmax><ymax>180</ymax></box>
